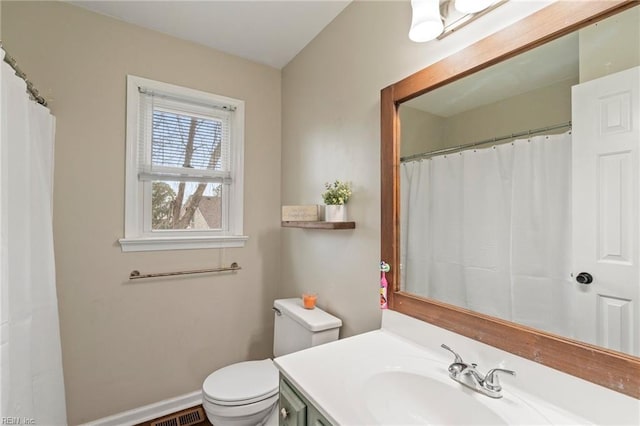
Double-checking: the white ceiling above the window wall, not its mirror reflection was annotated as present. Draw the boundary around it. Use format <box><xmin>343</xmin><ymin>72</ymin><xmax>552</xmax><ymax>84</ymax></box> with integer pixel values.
<box><xmin>69</xmin><ymin>0</ymin><xmax>351</xmax><ymax>69</ymax></box>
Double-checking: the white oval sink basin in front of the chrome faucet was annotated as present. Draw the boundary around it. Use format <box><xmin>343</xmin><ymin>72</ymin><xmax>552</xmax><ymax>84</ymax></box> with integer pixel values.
<box><xmin>348</xmin><ymin>357</ymin><xmax>550</xmax><ymax>425</ymax></box>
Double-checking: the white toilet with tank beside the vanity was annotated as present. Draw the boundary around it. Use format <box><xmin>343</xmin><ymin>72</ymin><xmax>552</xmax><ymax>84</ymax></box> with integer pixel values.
<box><xmin>202</xmin><ymin>298</ymin><xmax>342</xmax><ymax>426</ymax></box>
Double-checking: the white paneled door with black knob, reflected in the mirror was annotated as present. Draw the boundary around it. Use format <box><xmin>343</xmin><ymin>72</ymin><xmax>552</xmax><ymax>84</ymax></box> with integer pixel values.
<box><xmin>571</xmin><ymin>67</ymin><xmax>640</xmax><ymax>355</ymax></box>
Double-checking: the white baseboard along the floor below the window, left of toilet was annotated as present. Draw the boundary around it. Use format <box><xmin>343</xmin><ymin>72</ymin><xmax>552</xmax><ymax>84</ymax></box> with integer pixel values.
<box><xmin>80</xmin><ymin>390</ymin><xmax>202</xmax><ymax>426</ymax></box>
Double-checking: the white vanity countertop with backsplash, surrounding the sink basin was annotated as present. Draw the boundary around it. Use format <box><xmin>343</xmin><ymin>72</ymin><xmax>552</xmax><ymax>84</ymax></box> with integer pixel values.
<box><xmin>274</xmin><ymin>312</ymin><xmax>640</xmax><ymax>426</ymax></box>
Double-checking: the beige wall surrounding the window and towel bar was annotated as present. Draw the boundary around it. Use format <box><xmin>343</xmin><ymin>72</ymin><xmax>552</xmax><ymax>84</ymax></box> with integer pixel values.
<box><xmin>2</xmin><ymin>1</ymin><xmax>281</xmax><ymax>424</ymax></box>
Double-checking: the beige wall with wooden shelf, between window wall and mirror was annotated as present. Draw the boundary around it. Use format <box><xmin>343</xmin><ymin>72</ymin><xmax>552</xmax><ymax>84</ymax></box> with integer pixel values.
<box><xmin>281</xmin><ymin>1</ymin><xmax>548</xmax><ymax>336</ymax></box>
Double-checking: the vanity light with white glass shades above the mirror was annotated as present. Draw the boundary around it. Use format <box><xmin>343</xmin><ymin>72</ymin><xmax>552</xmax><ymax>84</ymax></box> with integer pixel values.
<box><xmin>409</xmin><ymin>0</ymin><xmax>507</xmax><ymax>43</ymax></box>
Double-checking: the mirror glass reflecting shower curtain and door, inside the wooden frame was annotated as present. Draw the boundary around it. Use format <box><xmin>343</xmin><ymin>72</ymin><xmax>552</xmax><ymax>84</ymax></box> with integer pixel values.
<box><xmin>399</xmin><ymin>7</ymin><xmax>640</xmax><ymax>356</ymax></box>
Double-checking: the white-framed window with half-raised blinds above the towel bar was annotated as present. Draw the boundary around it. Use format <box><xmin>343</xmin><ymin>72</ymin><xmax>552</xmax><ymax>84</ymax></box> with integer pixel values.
<box><xmin>120</xmin><ymin>76</ymin><xmax>247</xmax><ymax>251</ymax></box>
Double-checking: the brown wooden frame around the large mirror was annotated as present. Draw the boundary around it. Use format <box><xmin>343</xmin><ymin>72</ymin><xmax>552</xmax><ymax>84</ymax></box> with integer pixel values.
<box><xmin>381</xmin><ymin>0</ymin><xmax>640</xmax><ymax>399</ymax></box>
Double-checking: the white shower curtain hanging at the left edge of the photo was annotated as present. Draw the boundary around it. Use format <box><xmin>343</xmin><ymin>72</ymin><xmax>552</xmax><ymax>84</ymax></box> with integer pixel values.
<box><xmin>0</xmin><ymin>49</ymin><xmax>67</xmax><ymax>425</ymax></box>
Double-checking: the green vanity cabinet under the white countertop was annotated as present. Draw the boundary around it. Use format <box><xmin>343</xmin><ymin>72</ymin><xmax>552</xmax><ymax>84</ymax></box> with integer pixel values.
<box><xmin>278</xmin><ymin>376</ymin><xmax>331</xmax><ymax>426</ymax></box>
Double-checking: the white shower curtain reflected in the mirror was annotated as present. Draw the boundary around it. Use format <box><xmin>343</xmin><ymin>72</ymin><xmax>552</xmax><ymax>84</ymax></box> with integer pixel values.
<box><xmin>401</xmin><ymin>133</ymin><xmax>571</xmax><ymax>333</ymax></box>
